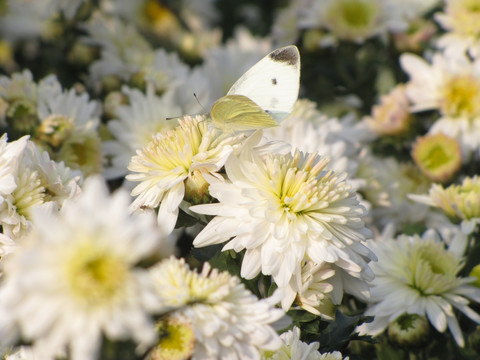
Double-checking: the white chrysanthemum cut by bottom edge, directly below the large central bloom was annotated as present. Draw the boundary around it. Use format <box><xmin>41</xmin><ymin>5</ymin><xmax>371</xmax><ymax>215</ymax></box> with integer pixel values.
<box><xmin>151</xmin><ymin>257</ymin><xmax>284</xmax><ymax>360</ymax></box>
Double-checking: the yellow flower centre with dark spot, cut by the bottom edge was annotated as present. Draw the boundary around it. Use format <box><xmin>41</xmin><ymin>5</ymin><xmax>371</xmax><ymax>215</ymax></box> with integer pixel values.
<box><xmin>149</xmin><ymin>319</ymin><xmax>195</xmax><ymax>360</ymax></box>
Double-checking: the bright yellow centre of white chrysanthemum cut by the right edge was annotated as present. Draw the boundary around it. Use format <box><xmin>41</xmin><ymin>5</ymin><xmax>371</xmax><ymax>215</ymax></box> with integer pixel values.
<box><xmin>440</xmin><ymin>75</ymin><xmax>480</xmax><ymax>117</ymax></box>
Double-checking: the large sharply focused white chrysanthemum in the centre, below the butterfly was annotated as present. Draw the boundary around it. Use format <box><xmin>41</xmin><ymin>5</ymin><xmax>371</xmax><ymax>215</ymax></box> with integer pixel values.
<box><xmin>190</xmin><ymin>132</ymin><xmax>375</xmax><ymax>287</ymax></box>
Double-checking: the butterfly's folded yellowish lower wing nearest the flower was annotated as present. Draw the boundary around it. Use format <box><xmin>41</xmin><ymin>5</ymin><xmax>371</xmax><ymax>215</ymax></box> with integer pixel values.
<box><xmin>211</xmin><ymin>95</ymin><xmax>277</xmax><ymax>131</ymax></box>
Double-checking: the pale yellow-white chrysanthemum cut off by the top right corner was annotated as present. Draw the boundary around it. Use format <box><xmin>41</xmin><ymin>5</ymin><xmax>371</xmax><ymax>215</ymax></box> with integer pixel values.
<box><xmin>435</xmin><ymin>0</ymin><xmax>480</xmax><ymax>58</ymax></box>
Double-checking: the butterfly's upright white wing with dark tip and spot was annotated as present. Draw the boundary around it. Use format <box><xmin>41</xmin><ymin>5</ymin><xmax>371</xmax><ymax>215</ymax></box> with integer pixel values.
<box><xmin>227</xmin><ymin>46</ymin><xmax>300</xmax><ymax>121</ymax></box>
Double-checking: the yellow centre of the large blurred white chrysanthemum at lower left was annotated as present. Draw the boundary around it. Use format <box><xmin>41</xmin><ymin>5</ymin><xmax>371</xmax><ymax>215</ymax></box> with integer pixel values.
<box><xmin>65</xmin><ymin>240</ymin><xmax>128</xmax><ymax>305</ymax></box>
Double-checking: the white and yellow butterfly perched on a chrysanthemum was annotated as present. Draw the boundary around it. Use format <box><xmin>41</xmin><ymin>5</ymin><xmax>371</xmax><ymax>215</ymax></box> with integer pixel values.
<box><xmin>210</xmin><ymin>45</ymin><xmax>300</xmax><ymax>131</ymax></box>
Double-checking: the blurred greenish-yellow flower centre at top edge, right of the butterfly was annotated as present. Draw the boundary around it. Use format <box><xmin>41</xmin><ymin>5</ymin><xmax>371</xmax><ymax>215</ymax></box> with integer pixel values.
<box><xmin>327</xmin><ymin>0</ymin><xmax>378</xmax><ymax>37</ymax></box>
